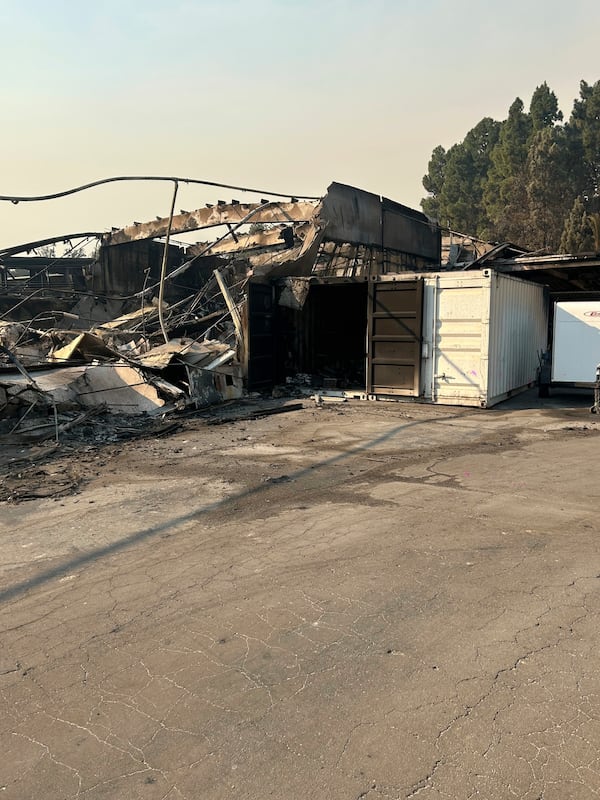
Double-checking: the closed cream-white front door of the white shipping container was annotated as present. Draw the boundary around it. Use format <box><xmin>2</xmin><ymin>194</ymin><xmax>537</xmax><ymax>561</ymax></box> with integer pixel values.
<box><xmin>433</xmin><ymin>286</ymin><xmax>489</xmax><ymax>405</ymax></box>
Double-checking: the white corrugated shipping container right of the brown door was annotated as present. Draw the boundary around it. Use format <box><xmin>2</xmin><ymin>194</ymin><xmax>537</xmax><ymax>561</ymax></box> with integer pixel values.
<box><xmin>421</xmin><ymin>269</ymin><xmax>548</xmax><ymax>408</ymax></box>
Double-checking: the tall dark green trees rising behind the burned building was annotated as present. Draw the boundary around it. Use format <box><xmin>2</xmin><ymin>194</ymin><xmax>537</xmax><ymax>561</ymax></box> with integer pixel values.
<box><xmin>421</xmin><ymin>81</ymin><xmax>600</xmax><ymax>253</ymax></box>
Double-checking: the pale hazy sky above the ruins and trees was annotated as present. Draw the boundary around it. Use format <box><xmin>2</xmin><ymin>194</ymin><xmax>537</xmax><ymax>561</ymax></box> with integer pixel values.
<box><xmin>0</xmin><ymin>0</ymin><xmax>600</xmax><ymax>247</ymax></box>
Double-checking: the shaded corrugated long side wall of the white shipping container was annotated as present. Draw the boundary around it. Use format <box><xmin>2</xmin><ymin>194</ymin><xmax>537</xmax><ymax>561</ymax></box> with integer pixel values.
<box><xmin>487</xmin><ymin>273</ymin><xmax>548</xmax><ymax>406</ymax></box>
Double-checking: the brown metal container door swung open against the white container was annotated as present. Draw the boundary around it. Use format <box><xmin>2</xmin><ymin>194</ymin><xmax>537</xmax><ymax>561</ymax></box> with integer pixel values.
<box><xmin>367</xmin><ymin>279</ymin><xmax>423</xmax><ymax>397</ymax></box>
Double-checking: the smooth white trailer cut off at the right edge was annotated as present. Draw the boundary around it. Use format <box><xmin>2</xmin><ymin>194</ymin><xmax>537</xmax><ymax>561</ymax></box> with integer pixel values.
<box><xmin>552</xmin><ymin>300</ymin><xmax>600</xmax><ymax>384</ymax></box>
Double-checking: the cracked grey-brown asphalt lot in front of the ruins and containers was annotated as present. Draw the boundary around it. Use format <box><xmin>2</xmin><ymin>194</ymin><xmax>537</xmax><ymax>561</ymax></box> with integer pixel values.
<box><xmin>0</xmin><ymin>395</ymin><xmax>600</xmax><ymax>800</ymax></box>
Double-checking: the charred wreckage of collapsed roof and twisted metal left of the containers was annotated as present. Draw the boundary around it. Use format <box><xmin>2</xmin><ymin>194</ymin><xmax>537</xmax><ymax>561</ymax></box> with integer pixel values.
<box><xmin>0</xmin><ymin>178</ymin><xmax>439</xmax><ymax>446</ymax></box>
